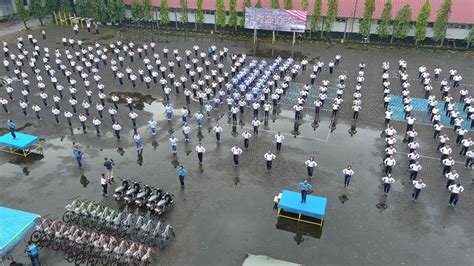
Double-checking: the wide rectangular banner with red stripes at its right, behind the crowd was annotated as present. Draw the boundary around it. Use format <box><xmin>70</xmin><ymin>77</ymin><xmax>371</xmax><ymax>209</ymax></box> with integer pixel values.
<box><xmin>245</xmin><ymin>7</ymin><xmax>307</xmax><ymax>32</ymax></box>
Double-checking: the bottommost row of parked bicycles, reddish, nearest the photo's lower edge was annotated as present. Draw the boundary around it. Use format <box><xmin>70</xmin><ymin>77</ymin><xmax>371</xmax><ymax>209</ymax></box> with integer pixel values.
<box><xmin>30</xmin><ymin>219</ymin><xmax>158</xmax><ymax>265</ymax></box>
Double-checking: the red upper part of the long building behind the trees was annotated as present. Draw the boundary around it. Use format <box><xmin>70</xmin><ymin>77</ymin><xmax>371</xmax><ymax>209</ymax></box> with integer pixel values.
<box><xmin>124</xmin><ymin>0</ymin><xmax>474</xmax><ymax>24</ymax></box>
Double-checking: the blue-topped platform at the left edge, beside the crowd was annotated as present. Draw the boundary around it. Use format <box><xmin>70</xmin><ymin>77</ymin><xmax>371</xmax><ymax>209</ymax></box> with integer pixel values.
<box><xmin>0</xmin><ymin>132</ymin><xmax>41</xmax><ymax>157</ymax></box>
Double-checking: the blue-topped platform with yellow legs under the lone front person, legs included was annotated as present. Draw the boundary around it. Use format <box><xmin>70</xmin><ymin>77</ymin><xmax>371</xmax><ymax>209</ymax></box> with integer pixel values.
<box><xmin>278</xmin><ymin>190</ymin><xmax>327</xmax><ymax>226</ymax></box>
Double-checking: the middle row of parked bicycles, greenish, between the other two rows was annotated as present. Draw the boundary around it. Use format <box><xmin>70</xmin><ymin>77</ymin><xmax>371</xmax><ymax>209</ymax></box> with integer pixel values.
<box><xmin>63</xmin><ymin>200</ymin><xmax>175</xmax><ymax>249</ymax></box>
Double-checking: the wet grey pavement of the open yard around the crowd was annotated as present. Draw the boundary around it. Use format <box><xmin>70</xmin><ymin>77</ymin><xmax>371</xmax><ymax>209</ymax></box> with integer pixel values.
<box><xmin>0</xmin><ymin>25</ymin><xmax>474</xmax><ymax>265</ymax></box>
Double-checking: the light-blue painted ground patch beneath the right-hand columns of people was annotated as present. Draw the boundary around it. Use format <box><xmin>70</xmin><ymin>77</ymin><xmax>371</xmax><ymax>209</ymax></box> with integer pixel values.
<box><xmin>388</xmin><ymin>95</ymin><xmax>471</xmax><ymax>131</ymax></box>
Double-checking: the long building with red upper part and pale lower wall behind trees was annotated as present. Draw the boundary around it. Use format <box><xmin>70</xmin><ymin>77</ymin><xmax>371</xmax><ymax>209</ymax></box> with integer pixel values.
<box><xmin>124</xmin><ymin>0</ymin><xmax>474</xmax><ymax>40</ymax></box>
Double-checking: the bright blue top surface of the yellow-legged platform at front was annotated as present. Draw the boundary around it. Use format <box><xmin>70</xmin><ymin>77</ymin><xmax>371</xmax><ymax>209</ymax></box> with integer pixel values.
<box><xmin>278</xmin><ymin>190</ymin><xmax>328</xmax><ymax>219</ymax></box>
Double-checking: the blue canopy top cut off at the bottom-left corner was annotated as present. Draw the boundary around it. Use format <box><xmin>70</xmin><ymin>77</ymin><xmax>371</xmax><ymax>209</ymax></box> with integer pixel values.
<box><xmin>0</xmin><ymin>207</ymin><xmax>40</xmax><ymax>257</ymax></box>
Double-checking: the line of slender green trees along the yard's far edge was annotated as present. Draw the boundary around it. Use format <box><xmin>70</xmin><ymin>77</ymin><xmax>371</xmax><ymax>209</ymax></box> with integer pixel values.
<box><xmin>15</xmin><ymin>0</ymin><xmax>474</xmax><ymax>46</ymax></box>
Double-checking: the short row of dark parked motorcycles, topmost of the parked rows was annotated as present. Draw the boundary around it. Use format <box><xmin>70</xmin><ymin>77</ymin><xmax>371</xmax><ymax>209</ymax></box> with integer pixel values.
<box><xmin>114</xmin><ymin>179</ymin><xmax>174</xmax><ymax>215</ymax></box>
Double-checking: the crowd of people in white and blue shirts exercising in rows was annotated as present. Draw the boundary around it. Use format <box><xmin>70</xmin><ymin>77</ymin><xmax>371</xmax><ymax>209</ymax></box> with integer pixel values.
<box><xmin>0</xmin><ymin>23</ymin><xmax>474</xmax><ymax>207</ymax></box>
